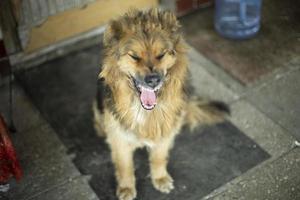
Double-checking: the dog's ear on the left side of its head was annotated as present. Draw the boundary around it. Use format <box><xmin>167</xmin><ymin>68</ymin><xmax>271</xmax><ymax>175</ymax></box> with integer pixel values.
<box><xmin>103</xmin><ymin>20</ymin><xmax>123</xmax><ymax>46</ymax></box>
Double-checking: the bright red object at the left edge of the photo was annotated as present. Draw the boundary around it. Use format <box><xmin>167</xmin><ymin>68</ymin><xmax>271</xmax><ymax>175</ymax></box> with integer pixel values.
<box><xmin>0</xmin><ymin>115</ymin><xmax>22</xmax><ymax>183</ymax></box>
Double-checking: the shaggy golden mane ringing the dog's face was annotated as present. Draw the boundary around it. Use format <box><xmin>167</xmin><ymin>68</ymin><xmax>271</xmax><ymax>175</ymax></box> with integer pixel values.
<box><xmin>100</xmin><ymin>9</ymin><xmax>188</xmax><ymax>139</ymax></box>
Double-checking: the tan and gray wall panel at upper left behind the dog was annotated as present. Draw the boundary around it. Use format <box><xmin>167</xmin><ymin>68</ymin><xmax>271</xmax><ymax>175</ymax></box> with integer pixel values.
<box><xmin>12</xmin><ymin>0</ymin><xmax>158</xmax><ymax>53</ymax></box>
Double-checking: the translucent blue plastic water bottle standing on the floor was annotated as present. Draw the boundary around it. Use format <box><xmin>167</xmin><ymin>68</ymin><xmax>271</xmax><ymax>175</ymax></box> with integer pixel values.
<box><xmin>215</xmin><ymin>0</ymin><xmax>262</xmax><ymax>39</ymax></box>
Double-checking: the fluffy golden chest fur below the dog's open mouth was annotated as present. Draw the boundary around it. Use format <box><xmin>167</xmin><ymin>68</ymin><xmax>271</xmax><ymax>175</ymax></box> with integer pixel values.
<box><xmin>105</xmin><ymin>70</ymin><xmax>186</xmax><ymax>141</ymax></box>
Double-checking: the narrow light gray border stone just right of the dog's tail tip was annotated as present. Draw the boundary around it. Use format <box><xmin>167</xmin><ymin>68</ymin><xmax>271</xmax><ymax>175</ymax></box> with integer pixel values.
<box><xmin>230</xmin><ymin>100</ymin><xmax>296</xmax><ymax>158</ymax></box>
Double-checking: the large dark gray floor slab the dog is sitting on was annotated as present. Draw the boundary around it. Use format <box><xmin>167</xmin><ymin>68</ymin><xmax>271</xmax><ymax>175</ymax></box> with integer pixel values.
<box><xmin>12</xmin><ymin>47</ymin><xmax>269</xmax><ymax>199</ymax></box>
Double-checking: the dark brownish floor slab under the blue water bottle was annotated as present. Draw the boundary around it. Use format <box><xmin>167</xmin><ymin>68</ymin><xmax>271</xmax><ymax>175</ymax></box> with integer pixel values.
<box><xmin>180</xmin><ymin>0</ymin><xmax>300</xmax><ymax>85</ymax></box>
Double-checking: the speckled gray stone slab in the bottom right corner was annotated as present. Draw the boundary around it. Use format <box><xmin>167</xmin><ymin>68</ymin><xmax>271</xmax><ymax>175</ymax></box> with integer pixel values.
<box><xmin>202</xmin><ymin>147</ymin><xmax>300</xmax><ymax>200</ymax></box>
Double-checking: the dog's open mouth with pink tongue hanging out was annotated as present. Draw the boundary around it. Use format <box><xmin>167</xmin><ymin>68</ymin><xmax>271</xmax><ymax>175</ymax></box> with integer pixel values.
<box><xmin>133</xmin><ymin>79</ymin><xmax>162</xmax><ymax>110</ymax></box>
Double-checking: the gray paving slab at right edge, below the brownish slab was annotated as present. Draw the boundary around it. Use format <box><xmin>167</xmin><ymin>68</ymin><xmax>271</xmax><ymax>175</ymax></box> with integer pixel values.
<box><xmin>247</xmin><ymin>67</ymin><xmax>300</xmax><ymax>140</ymax></box>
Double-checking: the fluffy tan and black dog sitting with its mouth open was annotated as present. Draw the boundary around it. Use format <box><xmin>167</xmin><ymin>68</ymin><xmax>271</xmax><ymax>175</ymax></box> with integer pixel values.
<box><xmin>94</xmin><ymin>9</ymin><xmax>228</xmax><ymax>200</ymax></box>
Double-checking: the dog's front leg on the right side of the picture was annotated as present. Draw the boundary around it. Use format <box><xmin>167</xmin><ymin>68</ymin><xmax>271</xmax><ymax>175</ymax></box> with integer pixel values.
<box><xmin>150</xmin><ymin>136</ymin><xmax>174</xmax><ymax>193</ymax></box>
